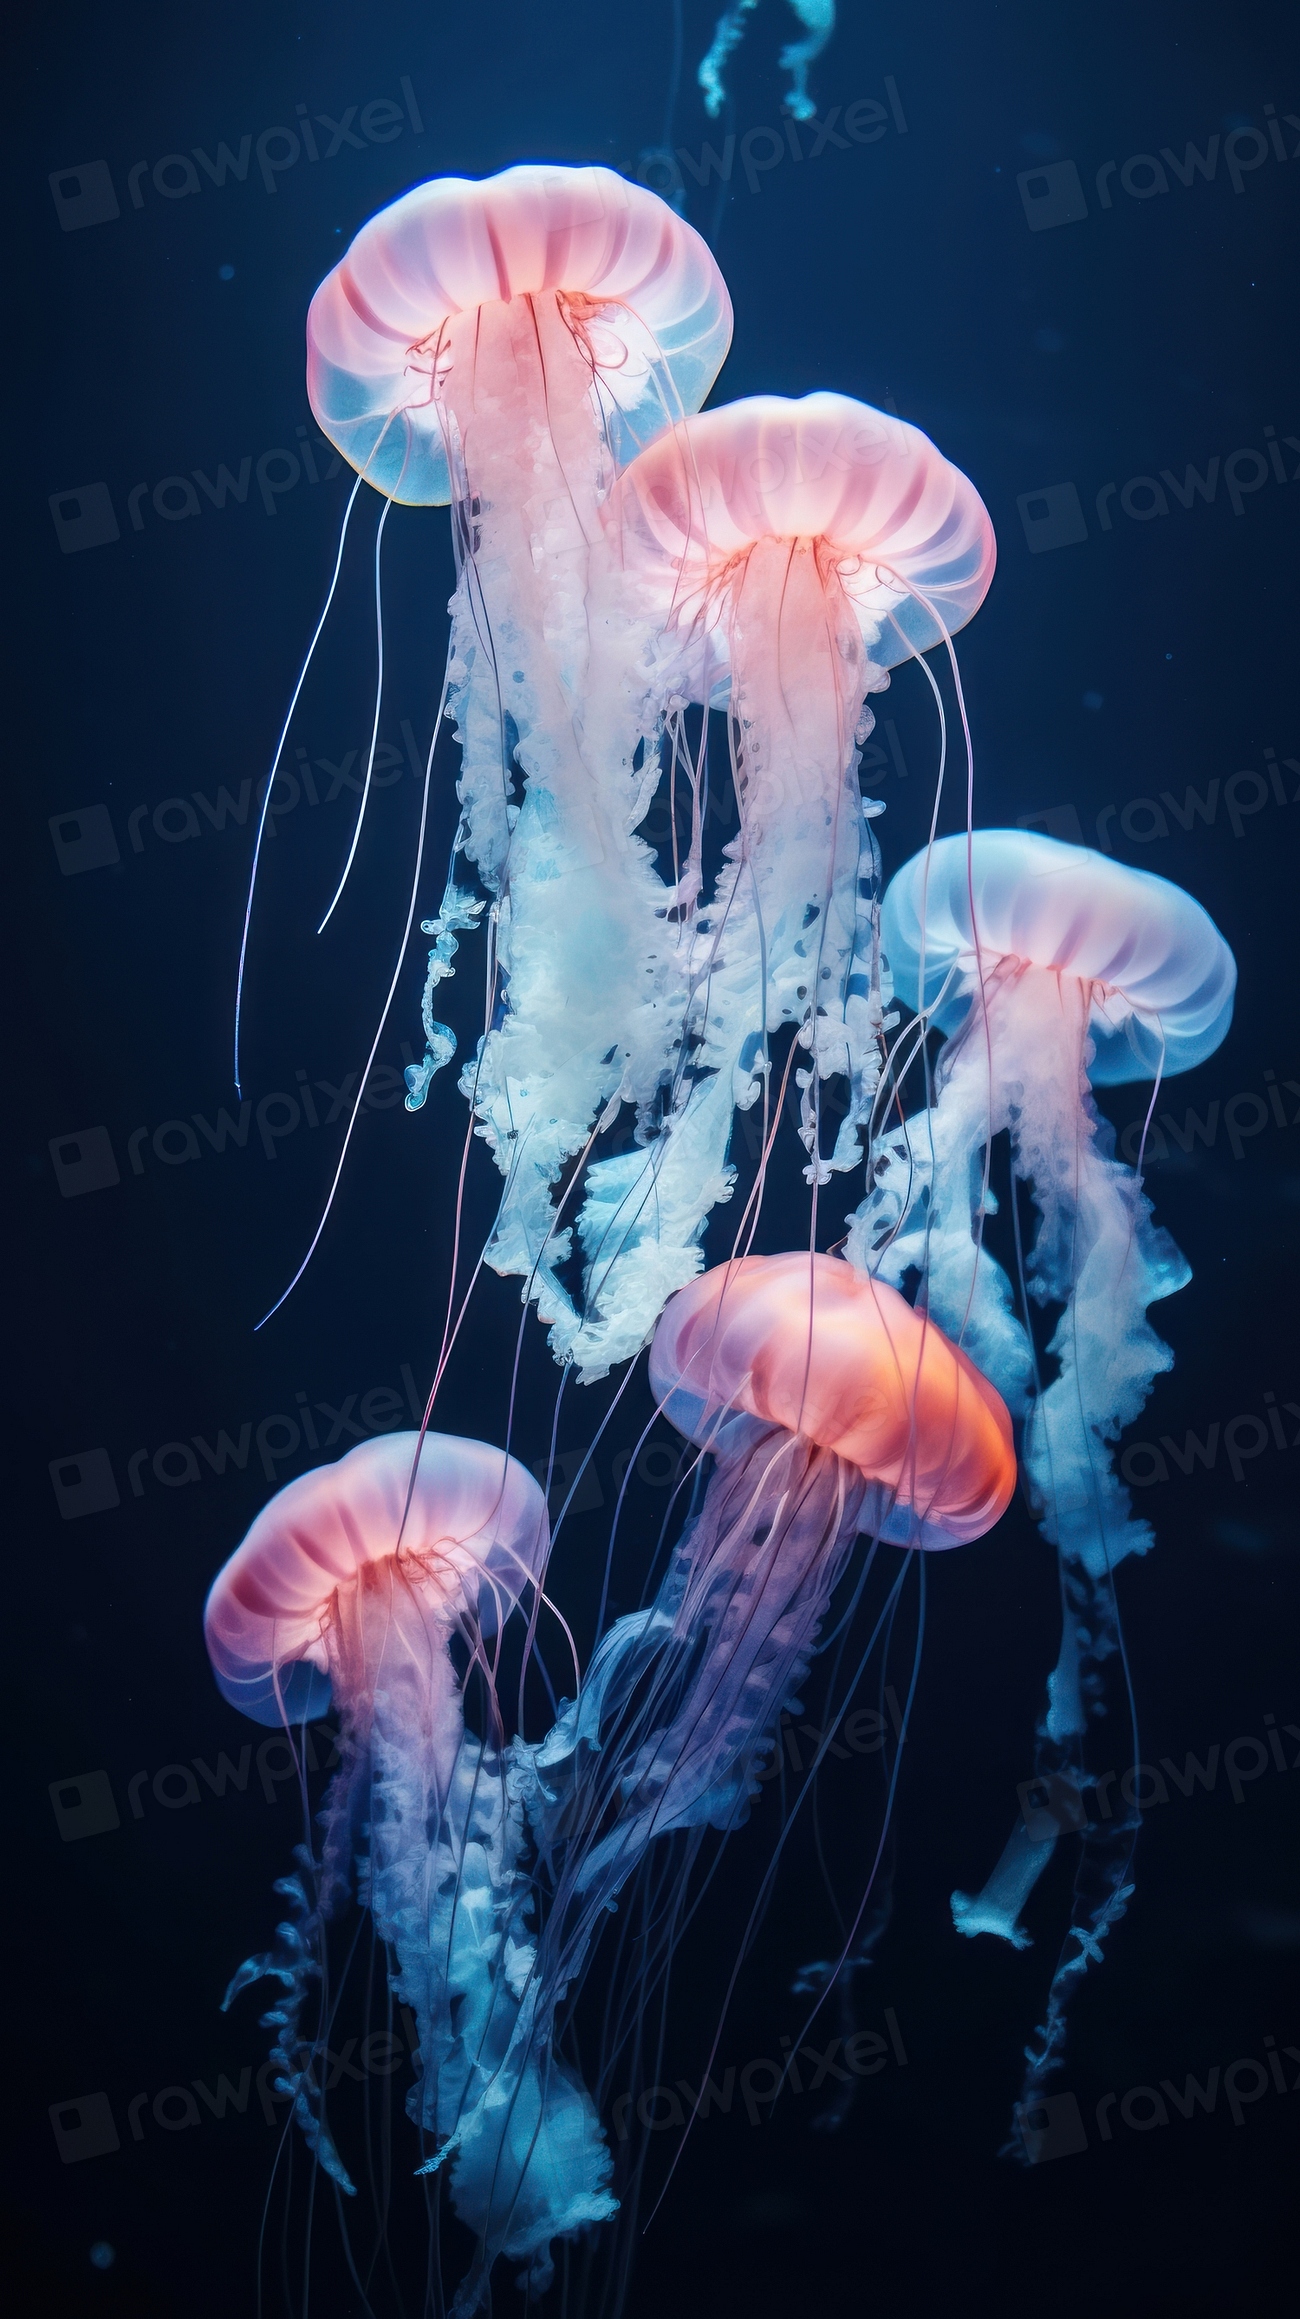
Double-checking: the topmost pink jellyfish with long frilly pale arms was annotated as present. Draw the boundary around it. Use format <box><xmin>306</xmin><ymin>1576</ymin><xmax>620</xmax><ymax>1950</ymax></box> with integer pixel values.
<box><xmin>308</xmin><ymin>165</ymin><xmax>732</xmax><ymax>1357</ymax></box>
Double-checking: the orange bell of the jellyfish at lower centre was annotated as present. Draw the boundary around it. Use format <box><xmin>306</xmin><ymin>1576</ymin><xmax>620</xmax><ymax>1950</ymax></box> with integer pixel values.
<box><xmin>651</xmin><ymin>1255</ymin><xmax>1015</xmax><ymax>1547</ymax></box>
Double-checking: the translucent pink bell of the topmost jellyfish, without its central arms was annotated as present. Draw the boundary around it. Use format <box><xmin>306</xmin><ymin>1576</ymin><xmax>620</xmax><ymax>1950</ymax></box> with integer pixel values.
<box><xmin>306</xmin><ymin>162</ymin><xmax>732</xmax><ymax>506</ymax></box>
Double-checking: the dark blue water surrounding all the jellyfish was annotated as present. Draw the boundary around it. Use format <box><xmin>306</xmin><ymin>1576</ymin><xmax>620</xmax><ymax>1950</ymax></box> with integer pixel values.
<box><xmin>5</xmin><ymin>0</ymin><xmax>1300</xmax><ymax>2319</ymax></box>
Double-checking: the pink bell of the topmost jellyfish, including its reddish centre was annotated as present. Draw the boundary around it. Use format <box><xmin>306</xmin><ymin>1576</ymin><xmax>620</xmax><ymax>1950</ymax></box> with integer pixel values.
<box><xmin>306</xmin><ymin>162</ymin><xmax>732</xmax><ymax>506</ymax></box>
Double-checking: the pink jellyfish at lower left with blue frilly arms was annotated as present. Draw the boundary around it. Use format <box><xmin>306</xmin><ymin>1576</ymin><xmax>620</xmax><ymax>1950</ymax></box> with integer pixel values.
<box><xmin>204</xmin><ymin>1433</ymin><xmax>614</xmax><ymax>2310</ymax></box>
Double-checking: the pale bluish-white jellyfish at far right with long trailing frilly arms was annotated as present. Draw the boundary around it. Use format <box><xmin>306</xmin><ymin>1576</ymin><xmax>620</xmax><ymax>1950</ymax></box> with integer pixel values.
<box><xmin>846</xmin><ymin>830</ymin><xmax>1237</xmax><ymax>2099</ymax></box>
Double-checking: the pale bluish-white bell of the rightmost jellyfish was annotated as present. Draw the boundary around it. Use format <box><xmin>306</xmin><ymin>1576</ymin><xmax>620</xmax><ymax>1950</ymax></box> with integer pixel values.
<box><xmin>881</xmin><ymin>830</ymin><xmax>1237</xmax><ymax>1085</ymax></box>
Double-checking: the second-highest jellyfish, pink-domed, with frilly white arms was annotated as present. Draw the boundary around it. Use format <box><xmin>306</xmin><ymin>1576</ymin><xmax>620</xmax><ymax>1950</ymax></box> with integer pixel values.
<box><xmin>570</xmin><ymin>394</ymin><xmax>994</xmax><ymax>1375</ymax></box>
